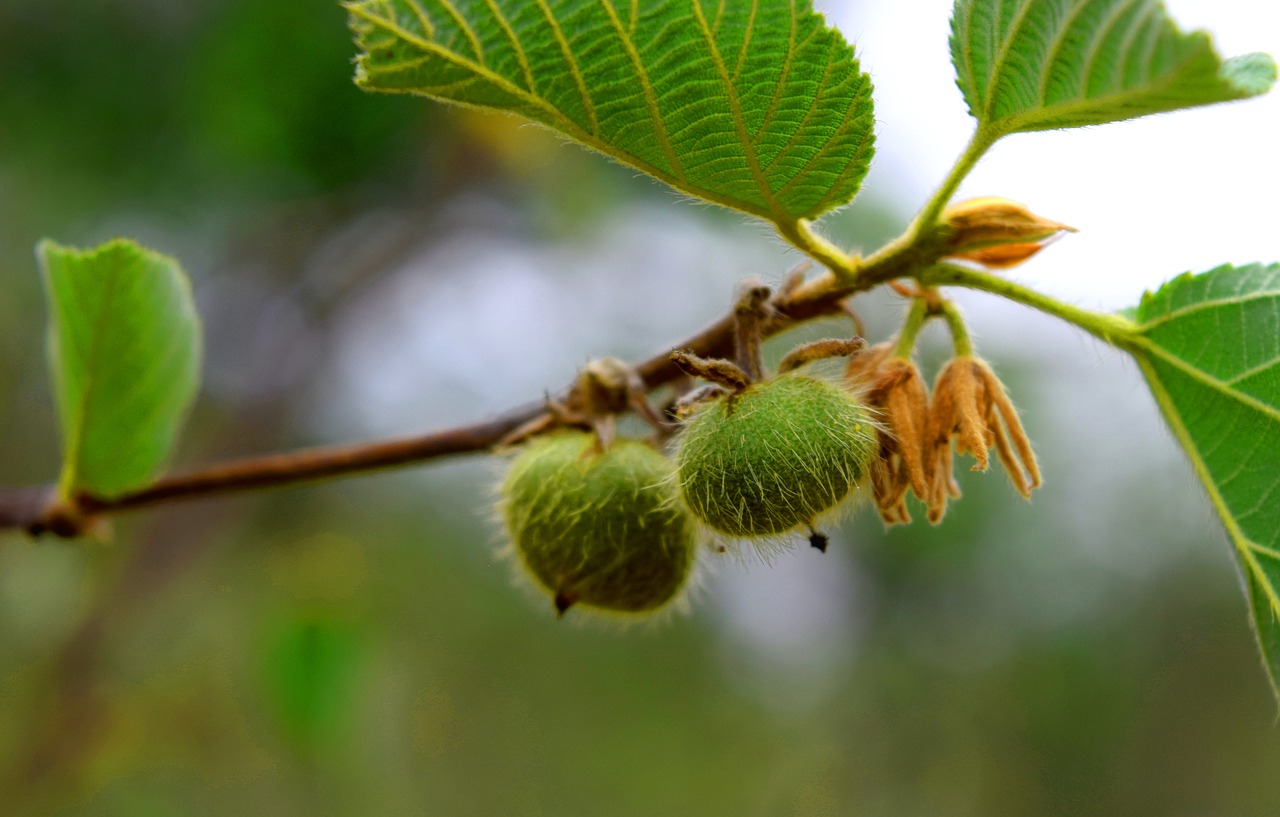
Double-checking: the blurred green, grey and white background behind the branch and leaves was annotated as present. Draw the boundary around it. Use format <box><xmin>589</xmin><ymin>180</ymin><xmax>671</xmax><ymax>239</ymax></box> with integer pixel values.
<box><xmin>0</xmin><ymin>0</ymin><xmax>1280</xmax><ymax>817</ymax></box>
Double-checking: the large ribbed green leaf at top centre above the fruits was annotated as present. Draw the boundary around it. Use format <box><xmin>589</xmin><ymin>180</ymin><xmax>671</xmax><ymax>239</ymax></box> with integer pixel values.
<box><xmin>347</xmin><ymin>0</ymin><xmax>874</xmax><ymax>224</ymax></box>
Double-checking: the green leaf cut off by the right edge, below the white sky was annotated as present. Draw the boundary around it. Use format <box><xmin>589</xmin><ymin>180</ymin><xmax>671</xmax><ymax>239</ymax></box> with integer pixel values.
<box><xmin>1134</xmin><ymin>264</ymin><xmax>1280</xmax><ymax>695</ymax></box>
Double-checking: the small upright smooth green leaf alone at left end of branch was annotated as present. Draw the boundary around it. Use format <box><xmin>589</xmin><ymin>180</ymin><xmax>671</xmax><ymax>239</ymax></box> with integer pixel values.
<box><xmin>37</xmin><ymin>239</ymin><xmax>200</xmax><ymax>498</ymax></box>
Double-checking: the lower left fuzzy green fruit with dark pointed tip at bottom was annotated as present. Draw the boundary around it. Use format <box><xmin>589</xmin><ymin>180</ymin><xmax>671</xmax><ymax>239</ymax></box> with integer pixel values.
<box><xmin>502</xmin><ymin>432</ymin><xmax>696</xmax><ymax>612</ymax></box>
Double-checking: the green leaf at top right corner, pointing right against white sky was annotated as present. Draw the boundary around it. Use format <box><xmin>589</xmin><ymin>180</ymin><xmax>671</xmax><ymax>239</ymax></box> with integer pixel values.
<box><xmin>951</xmin><ymin>0</ymin><xmax>1276</xmax><ymax>136</ymax></box>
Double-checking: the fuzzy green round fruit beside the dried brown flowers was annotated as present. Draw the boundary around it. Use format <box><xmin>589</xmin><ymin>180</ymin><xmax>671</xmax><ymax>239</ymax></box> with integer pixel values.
<box><xmin>676</xmin><ymin>374</ymin><xmax>876</xmax><ymax>537</ymax></box>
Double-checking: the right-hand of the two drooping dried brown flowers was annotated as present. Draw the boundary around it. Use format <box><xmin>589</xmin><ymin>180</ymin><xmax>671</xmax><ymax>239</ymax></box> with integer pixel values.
<box><xmin>925</xmin><ymin>355</ymin><xmax>1041</xmax><ymax>524</ymax></box>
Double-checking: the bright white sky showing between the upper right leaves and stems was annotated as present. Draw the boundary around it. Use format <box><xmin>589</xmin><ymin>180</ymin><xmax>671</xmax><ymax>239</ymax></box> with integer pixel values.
<box><xmin>817</xmin><ymin>0</ymin><xmax>1280</xmax><ymax>309</ymax></box>
